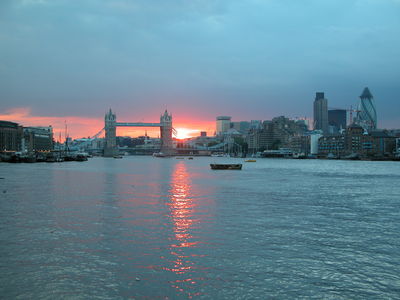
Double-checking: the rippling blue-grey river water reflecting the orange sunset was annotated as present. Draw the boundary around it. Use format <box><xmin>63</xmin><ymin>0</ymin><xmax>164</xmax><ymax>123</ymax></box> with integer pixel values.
<box><xmin>0</xmin><ymin>156</ymin><xmax>400</xmax><ymax>299</ymax></box>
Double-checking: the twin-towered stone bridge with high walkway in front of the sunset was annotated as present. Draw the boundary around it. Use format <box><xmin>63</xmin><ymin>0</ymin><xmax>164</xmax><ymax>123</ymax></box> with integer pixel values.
<box><xmin>104</xmin><ymin>108</ymin><xmax>175</xmax><ymax>157</ymax></box>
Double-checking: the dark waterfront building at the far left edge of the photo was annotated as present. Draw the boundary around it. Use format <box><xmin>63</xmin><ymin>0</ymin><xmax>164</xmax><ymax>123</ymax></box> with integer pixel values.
<box><xmin>0</xmin><ymin>121</ymin><xmax>23</xmax><ymax>151</ymax></box>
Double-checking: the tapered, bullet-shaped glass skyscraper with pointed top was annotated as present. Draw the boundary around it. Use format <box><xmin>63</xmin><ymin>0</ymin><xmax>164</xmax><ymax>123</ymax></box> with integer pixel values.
<box><xmin>356</xmin><ymin>87</ymin><xmax>377</xmax><ymax>130</ymax></box>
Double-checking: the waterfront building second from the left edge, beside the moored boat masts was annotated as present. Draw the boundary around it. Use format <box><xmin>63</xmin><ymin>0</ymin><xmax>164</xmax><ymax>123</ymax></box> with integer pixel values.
<box><xmin>22</xmin><ymin>126</ymin><xmax>54</xmax><ymax>152</ymax></box>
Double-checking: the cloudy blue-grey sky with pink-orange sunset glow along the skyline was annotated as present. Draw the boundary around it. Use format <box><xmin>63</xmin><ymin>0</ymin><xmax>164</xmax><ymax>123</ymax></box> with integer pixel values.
<box><xmin>0</xmin><ymin>0</ymin><xmax>400</xmax><ymax>138</ymax></box>
